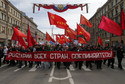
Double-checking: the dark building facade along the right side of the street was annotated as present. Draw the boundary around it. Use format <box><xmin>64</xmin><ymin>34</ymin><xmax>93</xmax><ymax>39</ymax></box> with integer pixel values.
<box><xmin>82</xmin><ymin>0</ymin><xmax>125</xmax><ymax>46</ymax></box>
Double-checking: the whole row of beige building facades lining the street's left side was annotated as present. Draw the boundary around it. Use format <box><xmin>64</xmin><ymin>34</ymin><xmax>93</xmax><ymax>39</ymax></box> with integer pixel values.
<box><xmin>0</xmin><ymin>0</ymin><xmax>43</xmax><ymax>45</ymax></box>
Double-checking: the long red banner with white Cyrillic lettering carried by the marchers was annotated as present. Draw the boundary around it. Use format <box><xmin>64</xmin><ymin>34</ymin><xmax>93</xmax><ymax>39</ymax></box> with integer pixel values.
<box><xmin>6</xmin><ymin>51</ymin><xmax>113</xmax><ymax>62</ymax></box>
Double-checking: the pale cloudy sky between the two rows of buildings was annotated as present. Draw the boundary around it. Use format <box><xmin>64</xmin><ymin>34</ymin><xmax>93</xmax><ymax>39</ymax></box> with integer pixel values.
<box><xmin>9</xmin><ymin>0</ymin><xmax>107</xmax><ymax>35</ymax></box>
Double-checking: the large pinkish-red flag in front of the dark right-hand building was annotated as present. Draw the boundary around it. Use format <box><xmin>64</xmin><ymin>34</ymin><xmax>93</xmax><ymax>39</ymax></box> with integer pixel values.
<box><xmin>98</xmin><ymin>16</ymin><xmax>123</xmax><ymax>36</ymax></box>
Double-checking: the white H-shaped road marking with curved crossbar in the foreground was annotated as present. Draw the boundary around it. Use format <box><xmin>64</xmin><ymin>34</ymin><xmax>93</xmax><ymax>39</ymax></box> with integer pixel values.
<box><xmin>48</xmin><ymin>66</ymin><xmax>74</xmax><ymax>84</ymax></box>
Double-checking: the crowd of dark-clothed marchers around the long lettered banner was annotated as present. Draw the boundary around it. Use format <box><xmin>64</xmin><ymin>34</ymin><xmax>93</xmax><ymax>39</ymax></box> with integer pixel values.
<box><xmin>0</xmin><ymin>45</ymin><xmax>125</xmax><ymax>70</ymax></box>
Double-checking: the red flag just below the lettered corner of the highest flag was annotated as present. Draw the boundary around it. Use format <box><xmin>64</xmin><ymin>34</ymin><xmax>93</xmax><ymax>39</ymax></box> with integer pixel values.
<box><xmin>65</xmin><ymin>28</ymin><xmax>77</xmax><ymax>39</ymax></box>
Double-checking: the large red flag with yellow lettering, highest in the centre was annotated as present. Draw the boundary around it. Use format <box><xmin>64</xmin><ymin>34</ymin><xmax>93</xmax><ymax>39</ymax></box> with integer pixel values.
<box><xmin>48</xmin><ymin>12</ymin><xmax>68</xmax><ymax>29</ymax></box>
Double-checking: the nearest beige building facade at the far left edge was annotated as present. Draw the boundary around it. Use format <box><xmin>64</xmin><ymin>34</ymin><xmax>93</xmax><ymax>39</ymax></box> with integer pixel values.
<box><xmin>0</xmin><ymin>0</ymin><xmax>22</xmax><ymax>45</ymax></box>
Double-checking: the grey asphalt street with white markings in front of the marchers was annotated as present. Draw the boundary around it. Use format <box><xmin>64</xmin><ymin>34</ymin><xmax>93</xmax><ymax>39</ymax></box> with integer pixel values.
<box><xmin>0</xmin><ymin>58</ymin><xmax>125</xmax><ymax>84</ymax></box>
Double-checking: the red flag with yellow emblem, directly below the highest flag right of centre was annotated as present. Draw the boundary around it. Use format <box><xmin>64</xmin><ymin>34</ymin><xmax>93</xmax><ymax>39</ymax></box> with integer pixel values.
<box><xmin>77</xmin><ymin>24</ymin><xmax>90</xmax><ymax>41</ymax></box>
